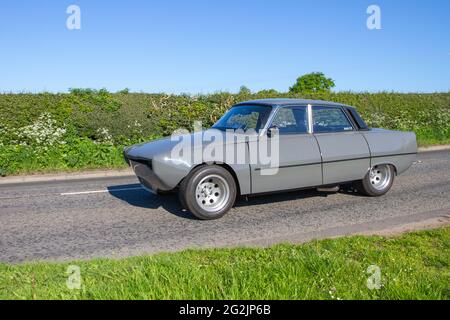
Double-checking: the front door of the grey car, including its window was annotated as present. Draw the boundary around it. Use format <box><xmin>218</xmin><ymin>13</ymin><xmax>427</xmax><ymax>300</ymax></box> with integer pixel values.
<box><xmin>249</xmin><ymin>106</ymin><xmax>322</xmax><ymax>193</ymax></box>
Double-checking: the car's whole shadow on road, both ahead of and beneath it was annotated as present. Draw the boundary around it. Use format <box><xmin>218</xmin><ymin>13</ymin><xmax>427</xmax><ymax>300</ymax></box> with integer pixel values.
<box><xmin>108</xmin><ymin>184</ymin><xmax>357</xmax><ymax>220</ymax></box>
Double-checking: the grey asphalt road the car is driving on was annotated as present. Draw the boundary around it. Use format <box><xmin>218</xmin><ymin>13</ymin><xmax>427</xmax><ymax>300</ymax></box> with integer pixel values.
<box><xmin>0</xmin><ymin>151</ymin><xmax>450</xmax><ymax>263</ymax></box>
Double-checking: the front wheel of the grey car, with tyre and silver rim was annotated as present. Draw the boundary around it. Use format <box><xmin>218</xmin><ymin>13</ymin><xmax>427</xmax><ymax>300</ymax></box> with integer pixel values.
<box><xmin>180</xmin><ymin>165</ymin><xmax>236</xmax><ymax>220</ymax></box>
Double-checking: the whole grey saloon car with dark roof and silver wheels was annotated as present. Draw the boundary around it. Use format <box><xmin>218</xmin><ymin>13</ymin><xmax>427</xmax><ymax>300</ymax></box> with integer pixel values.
<box><xmin>124</xmin><ymin>99</ymin><xmax>417</xmax><ymax>220</ymax></box>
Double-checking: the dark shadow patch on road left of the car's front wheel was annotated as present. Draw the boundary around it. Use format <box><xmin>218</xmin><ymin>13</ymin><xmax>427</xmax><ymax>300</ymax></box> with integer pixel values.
<box><xmin>107</xmin><ymin>184</ymin><xmax>196</xmax><ymax>219</ymax></box>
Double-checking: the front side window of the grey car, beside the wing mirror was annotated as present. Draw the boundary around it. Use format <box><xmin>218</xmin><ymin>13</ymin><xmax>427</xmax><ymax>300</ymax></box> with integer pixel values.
<box><xmin>272</xmin><ymin>107</ymin><xmax>308</xmax><ymax>134</ymax></box>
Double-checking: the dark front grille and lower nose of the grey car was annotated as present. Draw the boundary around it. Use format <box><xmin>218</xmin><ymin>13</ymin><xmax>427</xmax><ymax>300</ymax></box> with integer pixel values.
<box><xmin>124</xmin><ymin>151</ymin><xmax>171</xmax><ymax>193</ymax></box>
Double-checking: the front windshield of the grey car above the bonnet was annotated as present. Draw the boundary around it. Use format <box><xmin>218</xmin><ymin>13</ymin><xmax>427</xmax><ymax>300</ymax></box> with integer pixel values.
<box><xmin>213</xmin><ymin>105</ymin><xmax>272</xmax><ymax>131</ymax></box>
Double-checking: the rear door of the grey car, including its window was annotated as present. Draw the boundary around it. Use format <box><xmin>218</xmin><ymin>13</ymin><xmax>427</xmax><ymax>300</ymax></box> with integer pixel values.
<box><xmin>312</xmin><ymin>106</ymin><xmax>370</xmax><ymax>185</ymax></box>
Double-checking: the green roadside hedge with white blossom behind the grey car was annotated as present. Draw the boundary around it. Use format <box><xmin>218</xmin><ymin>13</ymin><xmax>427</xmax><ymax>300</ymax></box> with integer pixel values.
<box><xmin>0</xmin><ymin>85</ymin><xmax>450</xmax><ymax>176</ymax></box>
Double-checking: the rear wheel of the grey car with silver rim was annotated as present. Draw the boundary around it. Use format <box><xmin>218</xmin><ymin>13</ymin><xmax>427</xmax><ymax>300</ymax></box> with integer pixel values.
<box><xmin>356</xmin><ymin>164</ymin><xmax>395</xmax><ymax>197</ymax></box>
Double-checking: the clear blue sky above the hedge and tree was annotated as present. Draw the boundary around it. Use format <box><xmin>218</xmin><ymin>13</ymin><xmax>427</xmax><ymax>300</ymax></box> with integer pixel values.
<box><xmin>0</xmin><ymin>0</ymin><xmax>450</xmax><ymax>93</ymax></box>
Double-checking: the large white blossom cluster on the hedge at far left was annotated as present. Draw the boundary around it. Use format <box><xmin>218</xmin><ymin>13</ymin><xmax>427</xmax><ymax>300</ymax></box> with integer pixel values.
<box><xmin>17</xmin><ymin>112</ymin><xmax>66</xmax><ymax>146</ymax></box>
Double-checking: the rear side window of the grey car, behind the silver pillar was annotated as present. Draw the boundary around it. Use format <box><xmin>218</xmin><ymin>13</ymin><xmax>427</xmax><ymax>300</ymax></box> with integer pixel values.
<box><xmin>313</xmin><ymin>107</ymin><xmax>353</xmax><ymax>133</ymax></box>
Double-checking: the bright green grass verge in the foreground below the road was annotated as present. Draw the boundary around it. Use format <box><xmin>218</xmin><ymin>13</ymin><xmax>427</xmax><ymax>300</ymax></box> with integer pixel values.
<box><xmin>0</xmin><ymin>228</ymin><xmax>450</xmax><ymax>299</ymax></box>
